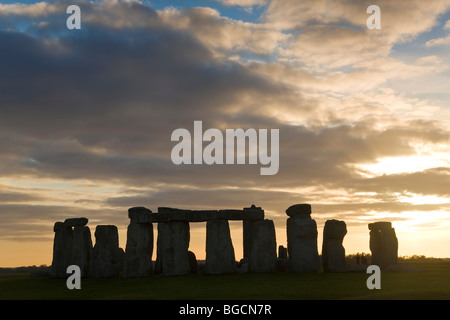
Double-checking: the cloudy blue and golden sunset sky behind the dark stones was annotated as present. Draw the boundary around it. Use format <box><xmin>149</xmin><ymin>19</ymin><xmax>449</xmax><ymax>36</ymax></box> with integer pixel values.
<box><xmin>0</xmin><ymin>0</ymin><xmax>450</xmax><ymax>267</ymax></box>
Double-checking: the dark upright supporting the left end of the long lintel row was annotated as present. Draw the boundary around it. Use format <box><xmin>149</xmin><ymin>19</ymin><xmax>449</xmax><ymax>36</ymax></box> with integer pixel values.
<box><xmin>123</xmin><ymin>223</ymin><xmax>153</xmax><ymax>277</ymax></box>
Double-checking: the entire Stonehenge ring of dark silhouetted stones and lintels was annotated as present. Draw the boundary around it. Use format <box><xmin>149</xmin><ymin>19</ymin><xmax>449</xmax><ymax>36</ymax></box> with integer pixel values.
<box><xmin>51</xmin><ymin>204</ymin><xmax>398</xmax><ymax>278</ymax></box>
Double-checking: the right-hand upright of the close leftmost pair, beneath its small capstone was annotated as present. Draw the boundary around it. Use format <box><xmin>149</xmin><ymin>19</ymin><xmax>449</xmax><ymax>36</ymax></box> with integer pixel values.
<box><xmin>70</xmin><ymin>225</ymin><xmax>93</xmax><ymax>277</ymax></box>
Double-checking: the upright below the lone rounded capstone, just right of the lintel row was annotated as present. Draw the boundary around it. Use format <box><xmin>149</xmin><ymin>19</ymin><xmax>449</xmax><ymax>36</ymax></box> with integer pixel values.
<box><xmin>286</xmin><ymin>217</ymin><xmax>320</xmax><ymax>272</ymax></box>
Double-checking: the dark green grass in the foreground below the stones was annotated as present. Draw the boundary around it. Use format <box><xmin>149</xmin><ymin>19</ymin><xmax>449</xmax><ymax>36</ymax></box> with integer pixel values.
<box><xmin>0</xmin><ymin>263</ymin><xmax>450</xmax><ymax>300</ymax></box>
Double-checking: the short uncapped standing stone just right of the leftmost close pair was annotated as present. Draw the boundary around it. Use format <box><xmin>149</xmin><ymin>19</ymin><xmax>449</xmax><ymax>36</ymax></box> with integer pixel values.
<box><xmin>91</xmin><ymin>225</ymin><xmax>124</xmax><ymax>278</ymax></box>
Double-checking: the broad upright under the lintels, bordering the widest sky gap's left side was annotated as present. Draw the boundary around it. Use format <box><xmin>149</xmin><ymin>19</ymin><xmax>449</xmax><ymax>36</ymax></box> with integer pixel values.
<box><xmin>155</xmin><ymin>221</ymin><xmax>190</xmax><ymax>276</ymax></box>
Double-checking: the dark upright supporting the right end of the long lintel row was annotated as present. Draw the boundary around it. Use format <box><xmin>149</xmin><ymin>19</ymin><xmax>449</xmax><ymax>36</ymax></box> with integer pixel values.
<box><xmin>249</xmin><ymin>219</ymin><xmax>277</xmax><ymax>272</ymax></box>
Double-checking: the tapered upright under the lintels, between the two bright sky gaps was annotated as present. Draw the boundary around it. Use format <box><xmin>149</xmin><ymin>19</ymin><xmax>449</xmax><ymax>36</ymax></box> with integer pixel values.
<box><xmin>205</xmin><ymin>220</ymin><xmax>237</xmax><ymax>274</ymax></box>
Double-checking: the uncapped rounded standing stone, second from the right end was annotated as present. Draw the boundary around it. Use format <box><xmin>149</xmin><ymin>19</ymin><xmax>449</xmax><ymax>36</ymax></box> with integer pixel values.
<box><xmin>322</xmin><ymin>219</ymin><xmax>347</xmax><ymax>272</ymax></box>
